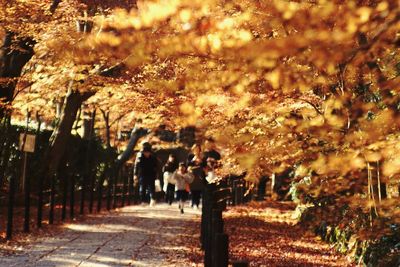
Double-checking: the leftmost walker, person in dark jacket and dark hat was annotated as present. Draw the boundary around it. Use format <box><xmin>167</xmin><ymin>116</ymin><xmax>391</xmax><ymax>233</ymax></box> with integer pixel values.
<box><xmin>134</xmin><ymin>142</ymin><xmax>158</xmax><ymax>206</ymax></box>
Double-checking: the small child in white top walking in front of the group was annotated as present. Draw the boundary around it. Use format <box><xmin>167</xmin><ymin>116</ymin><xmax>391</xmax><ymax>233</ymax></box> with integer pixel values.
<box><xmin>172</xmin><ymin>162</ymin><xmax>194</xmax><ymax>213</ymax></box>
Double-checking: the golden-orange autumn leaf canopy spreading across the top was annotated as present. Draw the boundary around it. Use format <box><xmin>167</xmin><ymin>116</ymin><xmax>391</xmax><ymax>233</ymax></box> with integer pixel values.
<box><xmin>0</xmin><ymin>0</ymin><xmax>400</xmax><ymax>234</ymax></box>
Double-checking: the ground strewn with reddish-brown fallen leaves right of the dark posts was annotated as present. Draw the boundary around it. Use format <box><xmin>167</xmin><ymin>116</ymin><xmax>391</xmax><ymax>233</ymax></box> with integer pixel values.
<box><xmin>224</xmin><ymin>201</ymin><xmax>354</xmax><ymax>267</ymax></box>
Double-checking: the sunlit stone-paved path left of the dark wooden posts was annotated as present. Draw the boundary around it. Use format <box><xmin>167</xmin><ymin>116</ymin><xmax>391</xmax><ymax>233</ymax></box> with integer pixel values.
<box><xmin>0</xmin><ymin>204</ymin><xmax>200</xmax><ymax>267</ymax></box>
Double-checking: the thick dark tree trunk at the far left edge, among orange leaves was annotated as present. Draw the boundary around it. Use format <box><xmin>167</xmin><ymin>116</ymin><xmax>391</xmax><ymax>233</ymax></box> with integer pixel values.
<box><xmin>0</xmin><ymin>32</ymin><xmax>35</xmax><ymax>118</ymax></box>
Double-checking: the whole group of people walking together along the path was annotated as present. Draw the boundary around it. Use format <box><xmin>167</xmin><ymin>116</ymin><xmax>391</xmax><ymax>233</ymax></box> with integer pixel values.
<box><xmin>134</xmin><ymin>142</ymin><xmax>221</xmax><ymax>213</ymax></box>
